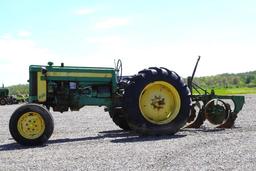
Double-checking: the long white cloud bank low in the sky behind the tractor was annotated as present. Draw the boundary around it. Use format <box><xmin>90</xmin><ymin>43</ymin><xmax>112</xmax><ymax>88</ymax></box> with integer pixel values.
<box><xmin>0</xmin><ymin>35</ymin><xmax>256</xmax><ymax>85</ymax></box>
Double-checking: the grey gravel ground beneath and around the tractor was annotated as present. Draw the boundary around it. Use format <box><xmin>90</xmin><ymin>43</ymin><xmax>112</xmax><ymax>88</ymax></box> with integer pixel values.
<box><xmin>0</xmin><ymin>95</ymin><xmax>256</xmax><ymax>171</ymax></box>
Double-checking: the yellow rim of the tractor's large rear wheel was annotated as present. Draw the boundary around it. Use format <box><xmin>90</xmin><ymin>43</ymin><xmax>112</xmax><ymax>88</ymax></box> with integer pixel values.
<box><xmin>139</xmin><ymin>81</ymin><xmax>181</xmax><ymax>125</ymax></box>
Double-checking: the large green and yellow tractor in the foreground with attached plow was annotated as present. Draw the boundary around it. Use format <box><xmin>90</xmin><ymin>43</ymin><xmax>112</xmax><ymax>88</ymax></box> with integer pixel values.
<box><xmin>9</xmin><ymin>57</ymin><xmax>244</xmax><ymax>146</ymax></box>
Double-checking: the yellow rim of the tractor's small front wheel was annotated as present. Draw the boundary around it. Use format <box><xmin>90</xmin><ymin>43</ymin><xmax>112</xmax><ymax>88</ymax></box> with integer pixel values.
<box><xmin>17</xmin><ymin>112</ymin><xmax>45</xmax><ymax>139</ymax></box>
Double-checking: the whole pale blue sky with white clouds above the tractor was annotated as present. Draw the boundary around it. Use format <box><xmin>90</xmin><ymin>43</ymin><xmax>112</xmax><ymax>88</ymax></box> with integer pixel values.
<box><xmin>0</xmin><ymin>0</ymin><xmax>256</xmax><ymax>85</ymax></box>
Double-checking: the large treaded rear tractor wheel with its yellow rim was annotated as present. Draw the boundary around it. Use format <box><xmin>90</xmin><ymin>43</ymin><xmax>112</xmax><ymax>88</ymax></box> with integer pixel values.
<box><xmin>124</xmin><ymin>67</ymin><xmax>191</xmax><ymax>135</ymax></box>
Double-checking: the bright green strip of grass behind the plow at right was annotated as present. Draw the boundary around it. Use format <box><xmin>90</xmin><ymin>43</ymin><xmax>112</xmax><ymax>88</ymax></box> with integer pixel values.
<box><xmin>202</xmin><ymin>87</ymin><xmax>256</xmax><ymax>95</ymax></box>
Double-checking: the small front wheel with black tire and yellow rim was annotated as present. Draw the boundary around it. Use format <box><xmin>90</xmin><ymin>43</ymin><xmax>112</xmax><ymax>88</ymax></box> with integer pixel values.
<box><xmin>9</xmin><ymin>104</ymin><xmax>54</xmax><ymax>146</ymax></box>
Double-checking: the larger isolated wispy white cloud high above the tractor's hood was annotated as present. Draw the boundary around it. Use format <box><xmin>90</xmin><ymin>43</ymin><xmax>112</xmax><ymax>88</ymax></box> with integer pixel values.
<box><xmin>96</xmin><ymin>18</ymin><xmax>129</xmax><ymax>29</ymax></box>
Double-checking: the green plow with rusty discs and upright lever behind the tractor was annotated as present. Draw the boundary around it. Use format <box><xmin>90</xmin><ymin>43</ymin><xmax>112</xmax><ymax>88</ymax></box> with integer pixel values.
<box><xmin>186</xmin><ymin>56</ymin><xmax>245</xmax><ymax>128</ymax></box>
